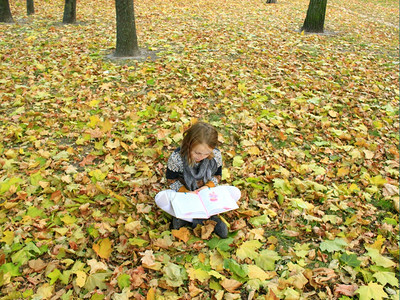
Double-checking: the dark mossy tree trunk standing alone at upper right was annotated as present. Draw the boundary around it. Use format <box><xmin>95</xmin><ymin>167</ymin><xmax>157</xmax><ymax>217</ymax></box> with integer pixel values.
<box><xmin>301</xmin><ymin>0</ymin><xmax>327</xmax><ymax>32</ymax></box>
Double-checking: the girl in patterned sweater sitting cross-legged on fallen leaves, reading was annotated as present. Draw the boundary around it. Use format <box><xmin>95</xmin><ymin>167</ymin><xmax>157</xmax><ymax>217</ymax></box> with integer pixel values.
<box><xmin>156</xmin><ymin>122</ymin><xmax>240</xmax><ymax>238</ymax></box>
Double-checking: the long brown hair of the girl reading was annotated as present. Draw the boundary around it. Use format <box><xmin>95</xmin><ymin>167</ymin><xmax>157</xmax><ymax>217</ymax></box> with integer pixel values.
<box><xmin>181</xmin><ymin>122</ymin><xmax>218</xmax><ymax>166</ymax></box>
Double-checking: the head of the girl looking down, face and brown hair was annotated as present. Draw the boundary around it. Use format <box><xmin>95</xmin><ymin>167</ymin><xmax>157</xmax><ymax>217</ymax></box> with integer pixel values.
<box><xmin>181</xmin><ymin>122</ymin><xmax>218</xmax><ymax>165</ymax></box>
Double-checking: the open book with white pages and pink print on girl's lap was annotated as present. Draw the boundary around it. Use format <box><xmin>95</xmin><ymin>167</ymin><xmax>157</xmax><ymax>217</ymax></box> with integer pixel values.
<box><xmin>171</xmin><ymin>186</ymin><xmax>239</xmax><ymax>219</ymax></box>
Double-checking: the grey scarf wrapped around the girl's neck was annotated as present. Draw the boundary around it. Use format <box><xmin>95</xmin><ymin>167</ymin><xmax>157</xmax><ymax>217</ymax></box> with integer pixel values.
<box><xmin>183</xmin><ymin>158</ymin><xmax>218</xmax><ymax>191</ymax></box>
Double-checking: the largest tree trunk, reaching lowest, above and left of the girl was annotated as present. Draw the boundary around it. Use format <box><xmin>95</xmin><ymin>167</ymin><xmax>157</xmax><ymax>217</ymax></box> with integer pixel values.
<box><xmin>114</xmin><ymin>0</ymin><xmax>140</xmax><ymax>57</ymax></box>
